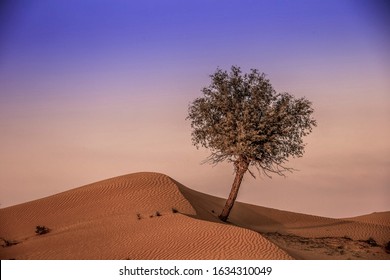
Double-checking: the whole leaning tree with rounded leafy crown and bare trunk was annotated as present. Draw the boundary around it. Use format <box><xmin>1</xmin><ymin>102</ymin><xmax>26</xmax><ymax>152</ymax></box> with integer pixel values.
<box><xmin>187</xmin><ymin>66</ymin><xmax>316</xmax><ymax>222</ymax></box>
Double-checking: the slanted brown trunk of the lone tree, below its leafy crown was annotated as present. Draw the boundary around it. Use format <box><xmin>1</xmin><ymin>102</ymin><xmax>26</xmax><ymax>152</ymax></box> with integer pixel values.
<box><xmin>219</xmin><ymin>157</ymin><xmax>249</xmax><ymax>222</ymax></box>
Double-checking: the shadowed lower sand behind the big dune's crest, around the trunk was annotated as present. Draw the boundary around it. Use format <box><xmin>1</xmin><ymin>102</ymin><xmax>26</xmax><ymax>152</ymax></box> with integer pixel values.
<box><xmin>180</xmin><ymin>185</ymin><xmax>390</xmax><ymax>259</ymax></box>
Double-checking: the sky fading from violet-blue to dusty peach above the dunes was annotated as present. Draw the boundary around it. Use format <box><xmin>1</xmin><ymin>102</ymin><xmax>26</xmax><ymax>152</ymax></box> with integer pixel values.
<box><xmin>0</xmin><ymin>0</ymin><xmax>390</xmax><ymax>217</ymax></box>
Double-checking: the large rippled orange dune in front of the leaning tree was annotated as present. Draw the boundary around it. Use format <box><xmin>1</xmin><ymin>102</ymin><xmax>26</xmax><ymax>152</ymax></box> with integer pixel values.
<box><xmin>0</xmin><ymin>173</ymin><xmax>291</xmax><ymax>259</ymax></box>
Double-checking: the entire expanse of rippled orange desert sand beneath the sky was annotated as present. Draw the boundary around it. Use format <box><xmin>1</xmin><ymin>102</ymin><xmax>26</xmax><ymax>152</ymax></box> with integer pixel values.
<box><xmin>0</xmin><ymin>172</ymin><xmax>390</xmax><ymax>260</ymax></box>
